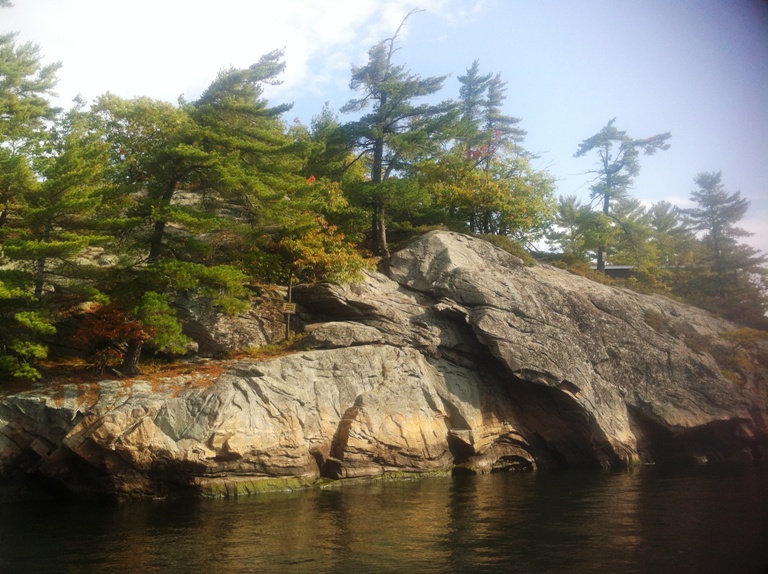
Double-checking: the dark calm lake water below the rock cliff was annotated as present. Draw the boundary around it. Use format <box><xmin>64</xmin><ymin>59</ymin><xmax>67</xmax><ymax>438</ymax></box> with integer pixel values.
<box><xmin>0</xmin><ymin>466</ymin><xmax>768</xmax><ymax>574</ymax></box>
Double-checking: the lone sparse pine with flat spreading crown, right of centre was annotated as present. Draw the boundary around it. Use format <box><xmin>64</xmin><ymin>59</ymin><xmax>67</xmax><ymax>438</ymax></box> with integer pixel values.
<box><xmin>574</xmin><ymin>118</ymin><xmax>672</xmax><ymax>271</ymax></box>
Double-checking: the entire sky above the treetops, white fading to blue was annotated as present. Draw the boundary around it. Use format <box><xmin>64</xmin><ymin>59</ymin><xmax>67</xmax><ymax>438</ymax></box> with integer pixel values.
<box><xmin>0</xmin><ymin>0</ymin><xmax>768</xmax><ymax>253</ymax></box>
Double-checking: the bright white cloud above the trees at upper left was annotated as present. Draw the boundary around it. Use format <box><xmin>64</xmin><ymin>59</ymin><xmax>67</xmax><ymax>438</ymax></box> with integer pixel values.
<box><xmin>3</xmin><ymin>0</ymin><xmax>445</xmax><ymax>105</ymax></box>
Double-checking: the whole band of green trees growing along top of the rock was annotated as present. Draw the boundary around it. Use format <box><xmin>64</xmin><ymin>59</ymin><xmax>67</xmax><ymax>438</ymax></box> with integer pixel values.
<box><xmin>0</xmin><ymin>9</ymin><xmax>768</xmax><ymax>379</ymax></box>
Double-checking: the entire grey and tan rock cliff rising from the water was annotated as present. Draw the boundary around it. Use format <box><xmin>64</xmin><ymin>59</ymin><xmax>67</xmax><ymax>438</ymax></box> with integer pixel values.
<box><xmin>0</xmin><ymin>232</ymin><xmax>767</xmax><ymax>496</ymax></box>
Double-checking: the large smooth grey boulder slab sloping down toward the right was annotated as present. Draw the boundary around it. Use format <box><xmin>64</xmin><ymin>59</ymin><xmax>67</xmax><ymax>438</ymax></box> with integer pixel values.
<box><xmin>390</xmin><ymin>233</ymin><xmax>766</xmax><ymax>464</ymax></box>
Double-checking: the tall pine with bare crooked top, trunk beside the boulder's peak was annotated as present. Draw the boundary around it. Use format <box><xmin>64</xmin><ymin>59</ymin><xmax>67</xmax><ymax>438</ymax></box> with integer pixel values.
<box><xmin>341</xmin><ymin>12</ymin><xmax>455</xmax><ymax>257</ymax></box>
